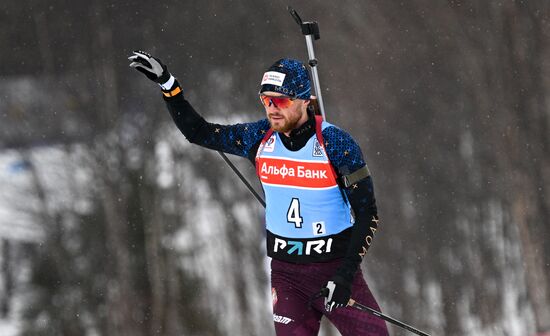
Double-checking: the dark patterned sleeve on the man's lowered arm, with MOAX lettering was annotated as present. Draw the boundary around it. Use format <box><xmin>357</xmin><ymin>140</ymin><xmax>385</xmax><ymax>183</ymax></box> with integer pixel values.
<box><xmin>323</xmin><ymin>126</ymin><xmax>378</xmax><ymax>280</ymax></box>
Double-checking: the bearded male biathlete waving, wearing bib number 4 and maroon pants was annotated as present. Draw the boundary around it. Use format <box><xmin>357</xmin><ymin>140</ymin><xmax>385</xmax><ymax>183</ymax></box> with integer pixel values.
<box><xmin>129</xmin><ymin>51</ymin><xmax>388</xmax><ymax>336</ymax></box>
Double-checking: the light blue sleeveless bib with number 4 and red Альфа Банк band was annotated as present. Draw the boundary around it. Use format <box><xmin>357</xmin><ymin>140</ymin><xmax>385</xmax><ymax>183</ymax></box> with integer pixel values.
<box><xmin>256</xmin><ymin>122</ymin><xmax>353</xmax><ymax>262</ymax></box>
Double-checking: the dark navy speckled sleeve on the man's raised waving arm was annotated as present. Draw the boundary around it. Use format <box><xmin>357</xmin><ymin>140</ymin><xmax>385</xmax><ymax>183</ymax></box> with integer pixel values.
<box><xmin>164</xmin><ymin>81</ymin><xmax>269</xmax><ymax>160</ymax></box>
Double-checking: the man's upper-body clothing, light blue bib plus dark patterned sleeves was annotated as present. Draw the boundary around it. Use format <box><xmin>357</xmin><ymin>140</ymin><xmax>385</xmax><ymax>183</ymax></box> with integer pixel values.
<box><xmin>165</xmin><ymin>90</ymin><xmax>376</xmax><ymax>263</ymax></box>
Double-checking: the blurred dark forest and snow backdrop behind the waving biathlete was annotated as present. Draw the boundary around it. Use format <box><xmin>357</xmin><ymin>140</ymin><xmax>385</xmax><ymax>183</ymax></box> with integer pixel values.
<box><xmin>0</xmin><ymin>0</ymin><xmax>550</xmax><ymax>336</ymax></box>
